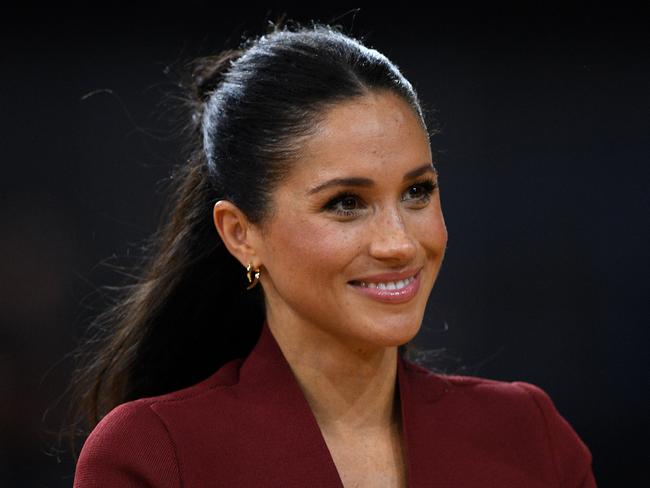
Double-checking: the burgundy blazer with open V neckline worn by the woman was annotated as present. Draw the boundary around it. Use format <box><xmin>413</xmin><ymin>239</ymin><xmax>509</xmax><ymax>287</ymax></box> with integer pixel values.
<box><xmin>74</xmin><ymin>322</ymin><xmax>596</xmax><ymax>488</ymax></box>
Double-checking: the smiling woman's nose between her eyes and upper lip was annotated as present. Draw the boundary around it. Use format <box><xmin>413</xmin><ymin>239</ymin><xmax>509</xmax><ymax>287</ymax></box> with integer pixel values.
<box><xmin>370</xmin><ymin>205</ymin><xmax>417</xmax><ymax>264</ymax></box>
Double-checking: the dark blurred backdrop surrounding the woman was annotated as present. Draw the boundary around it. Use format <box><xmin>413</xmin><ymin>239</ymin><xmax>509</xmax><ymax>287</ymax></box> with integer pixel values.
<box><xmin>0</xmin><ymin>1</ymin><xmax>650</xmax><ymax>487</ymax></box>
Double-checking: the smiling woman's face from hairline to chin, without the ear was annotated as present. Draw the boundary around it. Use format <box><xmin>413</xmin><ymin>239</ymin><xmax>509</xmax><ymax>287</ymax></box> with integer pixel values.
<box><xmin>256</xmin><ymin>92</ymin><xmax>447</xmax><ymax>349</ymax></box>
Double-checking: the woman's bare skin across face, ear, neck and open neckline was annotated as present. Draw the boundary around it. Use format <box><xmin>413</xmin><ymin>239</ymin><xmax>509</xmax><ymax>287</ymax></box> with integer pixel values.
<box><xmin>214</xmin><ymin>92</ymin><xmax>447</xmax><ymax>488</ymax></box>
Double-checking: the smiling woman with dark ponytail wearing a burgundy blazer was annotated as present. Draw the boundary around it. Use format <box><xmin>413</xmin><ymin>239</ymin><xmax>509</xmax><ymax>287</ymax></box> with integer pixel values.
<box><xmin>69</xmin><ymin>24</ymin><xmax>595</xmax><ymax>488</ymax></box>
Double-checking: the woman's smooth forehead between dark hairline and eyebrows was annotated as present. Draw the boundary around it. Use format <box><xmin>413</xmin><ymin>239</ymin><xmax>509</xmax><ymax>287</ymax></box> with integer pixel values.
<box><xmin>291</xmin><ymin>92</ymin><xmax>431</xmax><ymax>182</ymax></box>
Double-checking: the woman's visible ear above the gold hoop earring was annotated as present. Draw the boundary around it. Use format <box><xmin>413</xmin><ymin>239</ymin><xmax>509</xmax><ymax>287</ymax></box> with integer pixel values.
<box><xmin>212</xmin><ymin>200</ymin><xmax>262</xmax><ymax>268</ymax></box>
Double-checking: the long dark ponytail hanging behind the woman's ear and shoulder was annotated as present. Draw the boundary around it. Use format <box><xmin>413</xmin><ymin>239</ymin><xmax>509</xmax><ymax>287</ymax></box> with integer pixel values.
<box><xmin>65</xmin><ymin>44</ymin><xmax>264</xmax><ymax>454</ymax></box>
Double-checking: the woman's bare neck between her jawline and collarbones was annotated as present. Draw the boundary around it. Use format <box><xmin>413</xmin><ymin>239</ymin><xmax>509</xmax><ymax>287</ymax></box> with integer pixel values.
<box><xmin>268</xmin><ymin>320</ymin><xmax>399</xmax><ymax>434</ymax></box>
